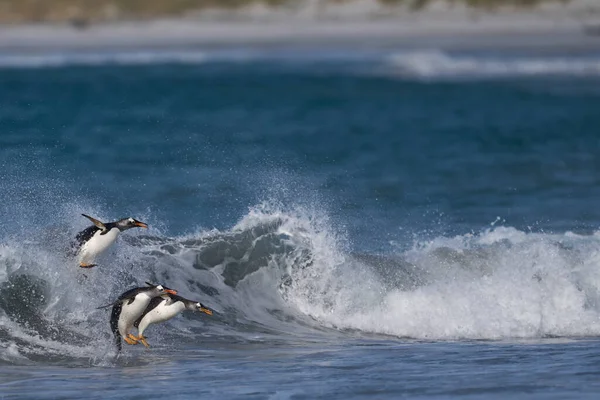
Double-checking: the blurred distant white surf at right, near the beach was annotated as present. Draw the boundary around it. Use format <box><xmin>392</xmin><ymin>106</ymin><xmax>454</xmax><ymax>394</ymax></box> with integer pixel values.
<box><xmin>387</xmin><ymin>50</ymin><xmax>600</xmax><ymax>79</ymax></box>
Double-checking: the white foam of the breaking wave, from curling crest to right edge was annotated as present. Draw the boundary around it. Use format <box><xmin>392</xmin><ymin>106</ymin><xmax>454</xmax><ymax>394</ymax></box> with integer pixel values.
<box><xmin>197</xmin><ymin>204</ymin><xmax>600</xmax><ymax>340</ymax></box>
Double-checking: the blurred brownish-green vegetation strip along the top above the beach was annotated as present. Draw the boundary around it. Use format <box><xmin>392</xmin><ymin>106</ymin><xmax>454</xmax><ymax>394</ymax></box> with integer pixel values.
<box><xmin>0</xmin><ymin>0</ymin><xmax>568</xmax><ymax>23</ymax></box>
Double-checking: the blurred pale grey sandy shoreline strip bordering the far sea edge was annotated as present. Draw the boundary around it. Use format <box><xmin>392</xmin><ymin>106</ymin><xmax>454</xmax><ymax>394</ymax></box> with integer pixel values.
<box><xmin>0</xmin><ymin>2</ymin><xmax>600</xmax><ymax>53</ymax></box>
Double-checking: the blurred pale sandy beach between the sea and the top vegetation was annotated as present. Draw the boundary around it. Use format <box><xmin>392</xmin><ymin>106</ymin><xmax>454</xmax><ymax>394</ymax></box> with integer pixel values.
<box><xmin>0</xmin><ymin>0</ymin><xmax>600</xmax><ymax>52</ymax></box>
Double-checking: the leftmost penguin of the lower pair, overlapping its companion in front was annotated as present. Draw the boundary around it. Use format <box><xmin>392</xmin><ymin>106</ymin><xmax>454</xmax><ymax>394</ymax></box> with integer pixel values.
<box><xmin>98</xmin><ymin>282</ymin><xmax>177</xmax><ymax>351</ymax></box>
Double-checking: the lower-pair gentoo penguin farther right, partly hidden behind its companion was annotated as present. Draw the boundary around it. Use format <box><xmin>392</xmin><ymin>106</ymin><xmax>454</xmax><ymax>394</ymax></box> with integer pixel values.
<box><xmin>133</xmin><ymin>294</ymin><xmax>213</xmax><ymax>347</ymax></box>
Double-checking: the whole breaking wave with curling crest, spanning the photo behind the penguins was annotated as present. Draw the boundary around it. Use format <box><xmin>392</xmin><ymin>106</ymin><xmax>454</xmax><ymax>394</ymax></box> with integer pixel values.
<box><xmin>0</xmin><ymin>199</ymin><xmax>600</xmax><ymax>364</ymax></box>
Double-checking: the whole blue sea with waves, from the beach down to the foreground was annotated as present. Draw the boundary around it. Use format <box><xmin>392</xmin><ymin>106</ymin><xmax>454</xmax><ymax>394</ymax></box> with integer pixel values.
<box><xmin>0</xmin><ymin>42</ymin><xmax>600</xmax><ymax>400</ymax></box>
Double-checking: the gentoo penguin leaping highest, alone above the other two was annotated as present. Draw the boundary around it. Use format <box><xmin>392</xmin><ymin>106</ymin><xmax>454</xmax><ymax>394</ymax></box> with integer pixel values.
<box><xmin>75</xmin><ymin>214</ymin><xmax>148</xmax><ymax>268</ymax></box>
